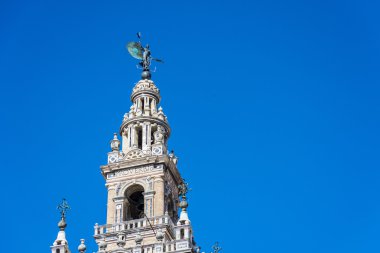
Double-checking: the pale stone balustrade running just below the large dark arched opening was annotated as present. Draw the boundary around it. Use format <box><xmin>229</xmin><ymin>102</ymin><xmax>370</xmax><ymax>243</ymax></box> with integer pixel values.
<box><xmin>94</xmin><ymin>215</ymin><xmax>175</xmax><ymax>236</ymax></box>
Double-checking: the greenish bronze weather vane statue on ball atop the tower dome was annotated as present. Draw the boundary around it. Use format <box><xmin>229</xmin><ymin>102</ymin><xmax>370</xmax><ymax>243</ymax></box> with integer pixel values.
<box><xmin>127</xmin><ymin>32</ymin><xmax>163</xmax><ymax>79</ymax></box>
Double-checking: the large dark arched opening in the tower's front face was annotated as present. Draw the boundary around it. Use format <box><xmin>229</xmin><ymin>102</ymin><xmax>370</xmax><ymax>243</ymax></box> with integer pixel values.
<box><xmin>124</xmin><ymin>184</ymin><xmax>145</xmax><ymax>220</ymax></box>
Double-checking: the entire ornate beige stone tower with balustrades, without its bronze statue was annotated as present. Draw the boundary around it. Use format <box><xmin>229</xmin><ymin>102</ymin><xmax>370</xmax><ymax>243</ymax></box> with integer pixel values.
<box><xmin>94</xmin><ymin>75</ymin><xmax>199</xmax><ymax>253</ymax></box>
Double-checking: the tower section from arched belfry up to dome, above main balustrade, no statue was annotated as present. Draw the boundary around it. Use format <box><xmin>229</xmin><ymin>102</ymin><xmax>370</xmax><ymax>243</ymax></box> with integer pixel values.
<box><xmin>101</xmin><ymin>79</ymin><xmax>174</xmax><ymax>224</ymax></box>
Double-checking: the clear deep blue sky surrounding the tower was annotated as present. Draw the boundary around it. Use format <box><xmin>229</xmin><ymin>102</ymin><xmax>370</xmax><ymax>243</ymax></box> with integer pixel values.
<box><xmin>0</xmin><ymin>0</ymin><xmax>380</xmax><ymax>253</ymax></box>
